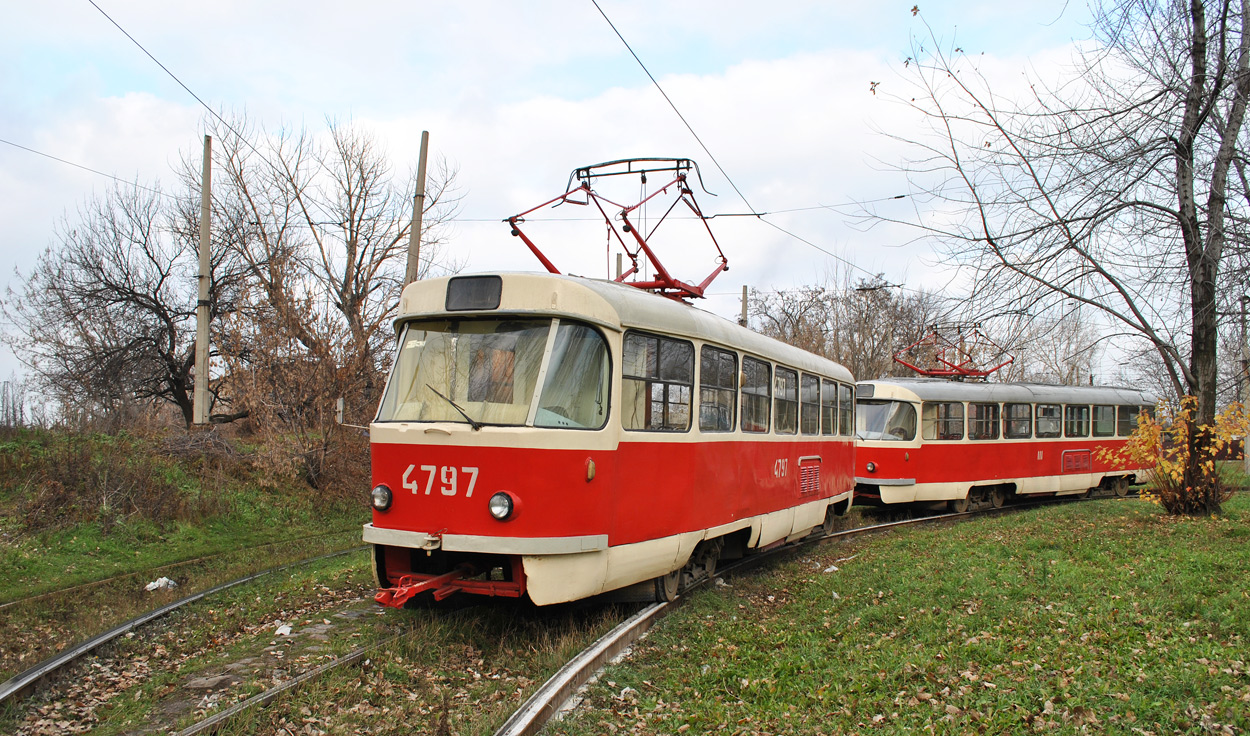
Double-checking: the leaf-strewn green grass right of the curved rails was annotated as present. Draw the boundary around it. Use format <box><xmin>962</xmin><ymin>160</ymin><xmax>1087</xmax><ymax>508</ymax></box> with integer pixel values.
<box><xmin>549</xmin><ymin>495</ymin><xmax>1250</xmax><ymax>735</ymax></box>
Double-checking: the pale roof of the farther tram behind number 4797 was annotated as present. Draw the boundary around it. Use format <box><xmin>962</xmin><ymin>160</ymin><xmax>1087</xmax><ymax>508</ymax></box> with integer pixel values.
<box><xmin>860</xmin><ymin>376</ymin><xmax>1156</xmax><ymax>405</ymax></box>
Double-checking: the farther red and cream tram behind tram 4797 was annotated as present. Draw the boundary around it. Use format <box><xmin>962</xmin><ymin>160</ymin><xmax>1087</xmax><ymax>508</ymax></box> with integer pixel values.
<box><xmin>855</xmin><ymin>377</ymin><xmax>1155</xmax><ymax>511</ymax></box>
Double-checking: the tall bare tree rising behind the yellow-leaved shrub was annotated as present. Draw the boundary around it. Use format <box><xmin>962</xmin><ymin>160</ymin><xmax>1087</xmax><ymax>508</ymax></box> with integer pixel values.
<box><xmin>890</xmin><ymin>0</ymin><xmax>1250</xmax><ymax>512</ymax></box>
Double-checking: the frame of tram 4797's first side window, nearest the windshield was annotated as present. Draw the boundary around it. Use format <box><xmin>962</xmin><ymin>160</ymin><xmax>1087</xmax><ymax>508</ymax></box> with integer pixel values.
<box><xmin>621</xmin><ymin>331</ymin><xmax>695</xmax><ymax>432</ymax></box>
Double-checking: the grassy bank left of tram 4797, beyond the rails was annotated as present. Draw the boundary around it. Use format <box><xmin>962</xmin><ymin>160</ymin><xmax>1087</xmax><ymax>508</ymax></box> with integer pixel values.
<box><xmin>0</xmin><ymin>430</ymin><xmax>369</xmax><ymax>604</ymax></box>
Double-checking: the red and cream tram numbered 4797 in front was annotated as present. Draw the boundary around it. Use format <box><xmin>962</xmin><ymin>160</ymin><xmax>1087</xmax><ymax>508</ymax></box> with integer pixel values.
<box><xmin>364</xmin><ymin>274</ymin><xmax>855</xmax><ymax>606</ymax></box>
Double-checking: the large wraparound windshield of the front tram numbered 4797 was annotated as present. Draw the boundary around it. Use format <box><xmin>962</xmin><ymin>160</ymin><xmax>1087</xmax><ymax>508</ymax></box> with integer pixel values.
<box><xmin>378</xmin><ymin>319</ymin><xmax>610</xmax><ymax>429</ymax></box>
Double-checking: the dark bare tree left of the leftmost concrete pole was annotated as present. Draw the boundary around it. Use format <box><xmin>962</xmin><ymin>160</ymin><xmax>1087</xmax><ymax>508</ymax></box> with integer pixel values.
<box><xmin>4</xmin><ymin>185</ymin><xmax>210</xmax><ymax>422</ymax></box>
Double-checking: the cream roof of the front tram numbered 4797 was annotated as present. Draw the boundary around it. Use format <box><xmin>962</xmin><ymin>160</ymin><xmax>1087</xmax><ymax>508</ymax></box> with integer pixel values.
<box><xmin>396</xmin><ymin>272</ymin><xmax>855</xmax><ymax>382</ymax></box>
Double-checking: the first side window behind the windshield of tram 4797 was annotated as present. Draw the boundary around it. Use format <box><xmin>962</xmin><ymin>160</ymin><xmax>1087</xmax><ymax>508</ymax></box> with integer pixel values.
<box><xmin>621</xmin><ymin>332</ymin><xmax>695</xmax><ymax>432</ymax></box>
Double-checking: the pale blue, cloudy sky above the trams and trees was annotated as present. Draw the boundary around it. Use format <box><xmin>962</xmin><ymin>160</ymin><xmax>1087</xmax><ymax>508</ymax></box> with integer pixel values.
<box><xmin>0</xmin><ymin>0</ymin><xmax>1088</xmax><ymax>379</ymax></box>
